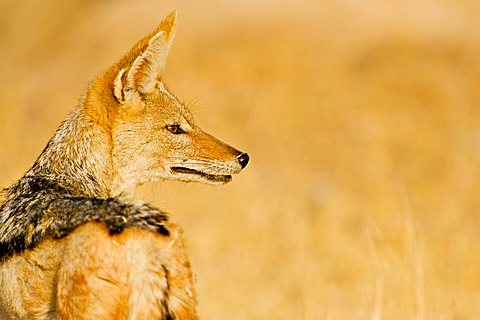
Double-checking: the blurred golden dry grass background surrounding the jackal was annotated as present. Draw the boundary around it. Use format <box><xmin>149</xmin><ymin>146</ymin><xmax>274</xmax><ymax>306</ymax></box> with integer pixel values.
<box><xmin>0</xmin><ymin>0</ymin><xmax>480</xmax><ymax>320</ymax></box>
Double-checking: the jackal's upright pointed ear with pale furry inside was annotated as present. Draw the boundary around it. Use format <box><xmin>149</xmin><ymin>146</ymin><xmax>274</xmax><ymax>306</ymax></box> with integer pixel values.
<box><xmin>125</xmin><ymin>12</ymin><xmax>177</xmax><ymax>93</ymax></box>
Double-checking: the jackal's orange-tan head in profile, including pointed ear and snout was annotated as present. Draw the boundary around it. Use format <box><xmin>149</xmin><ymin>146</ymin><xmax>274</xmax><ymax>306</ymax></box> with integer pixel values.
<box><xmin>87</xmin><ymin>12</ymin><xmax>249</xmax><ymax>191</ymax></box>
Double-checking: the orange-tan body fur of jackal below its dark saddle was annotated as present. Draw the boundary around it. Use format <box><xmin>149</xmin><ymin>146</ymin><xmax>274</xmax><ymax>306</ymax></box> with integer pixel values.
<box><xmin>0</xmin><ymin>222</ymin><xmax>197</xmax><ymax>319</ymax></box>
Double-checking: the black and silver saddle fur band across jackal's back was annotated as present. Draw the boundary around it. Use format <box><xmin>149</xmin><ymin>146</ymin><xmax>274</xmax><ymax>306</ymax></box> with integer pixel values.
<box><xmin>0</xmin><ymin>176</ymin><xmax>169</xmax><ymax>261</ymax></box>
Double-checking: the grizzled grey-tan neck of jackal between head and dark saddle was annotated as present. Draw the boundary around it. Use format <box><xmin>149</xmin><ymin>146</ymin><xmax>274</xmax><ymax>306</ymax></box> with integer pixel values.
<box><xmin>26</xmin><ymin>106</ymin><xmax>113</xmax><ymax>198</ymax></box>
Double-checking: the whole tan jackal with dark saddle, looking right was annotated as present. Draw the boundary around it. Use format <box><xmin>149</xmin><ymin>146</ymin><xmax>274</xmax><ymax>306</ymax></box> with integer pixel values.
<box><xmin>0</xmin><ymin>12</ymin><xmax>249</xmax><ymax>319</ymax></box>
